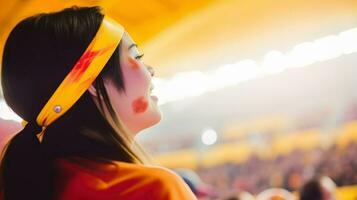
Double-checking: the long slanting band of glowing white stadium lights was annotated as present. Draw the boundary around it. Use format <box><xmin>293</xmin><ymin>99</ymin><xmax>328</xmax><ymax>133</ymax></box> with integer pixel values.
<box><xmin>155</xmin><ymin>28</ymin><xmax>357</xmax><ymax>105</ymax></box>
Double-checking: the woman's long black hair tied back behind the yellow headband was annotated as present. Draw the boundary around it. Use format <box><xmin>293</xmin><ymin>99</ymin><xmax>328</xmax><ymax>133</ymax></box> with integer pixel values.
<box><xmin>0</xmin><ymin>7</ymin><xmax>142</xmax><ymax>200</ymax></box>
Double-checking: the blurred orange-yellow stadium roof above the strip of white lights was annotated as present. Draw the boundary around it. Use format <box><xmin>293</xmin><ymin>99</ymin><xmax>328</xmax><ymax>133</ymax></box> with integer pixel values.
<box><xmin>0</xmin><ymin>0</ymin><xmax>357</xmax><ymax>76</ymax></box>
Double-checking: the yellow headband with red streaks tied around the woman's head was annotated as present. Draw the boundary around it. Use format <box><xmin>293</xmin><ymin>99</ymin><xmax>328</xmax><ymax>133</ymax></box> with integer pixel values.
<box><xmin>23</xmin><ymin>16</ymin><xmax>124</xmax><ymax>140</ymax></box>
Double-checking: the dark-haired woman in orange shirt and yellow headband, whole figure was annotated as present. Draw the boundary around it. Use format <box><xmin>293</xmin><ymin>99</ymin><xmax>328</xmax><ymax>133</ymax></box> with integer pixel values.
<box><xmin>0</xmin><ymin>7</ymin><xmax>195</xmax><ymax>200</ymax></box>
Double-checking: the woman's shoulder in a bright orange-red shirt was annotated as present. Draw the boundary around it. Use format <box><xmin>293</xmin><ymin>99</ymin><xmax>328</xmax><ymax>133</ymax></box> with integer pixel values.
<box><xmin>57</xmin><ymin>160</ymin><xmax>195</xmax><ymax>200</ymax></box>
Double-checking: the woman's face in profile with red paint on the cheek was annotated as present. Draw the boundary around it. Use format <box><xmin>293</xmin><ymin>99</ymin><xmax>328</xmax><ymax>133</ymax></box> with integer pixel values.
<box><xmin>105</xmin><ymin>33</ymin><xmax>161</xmax><ymax>134</ymax></box>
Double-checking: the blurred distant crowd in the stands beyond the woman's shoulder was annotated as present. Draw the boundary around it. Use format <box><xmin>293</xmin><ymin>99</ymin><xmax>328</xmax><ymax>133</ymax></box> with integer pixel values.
<box><xmin>197</xmin><ymin>143</ymin><xmax>357</xmax><ymax>194</ymax></box>
